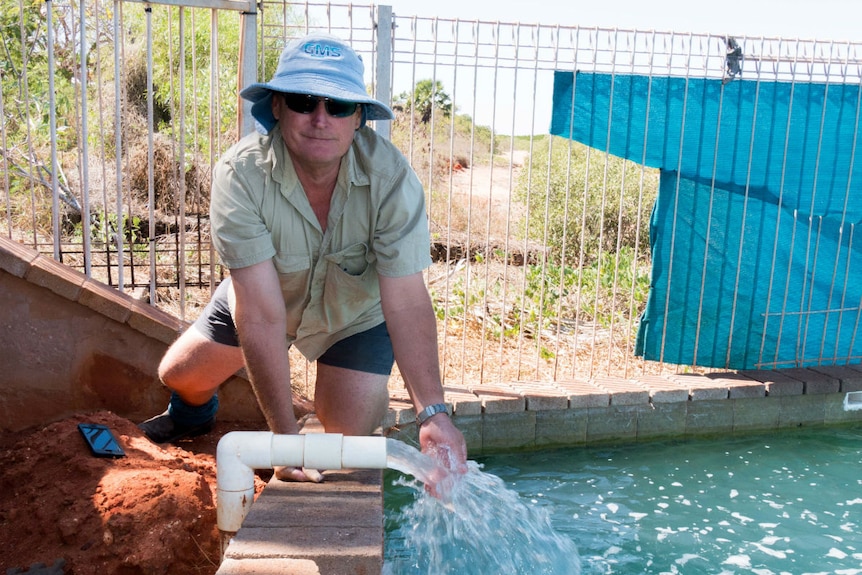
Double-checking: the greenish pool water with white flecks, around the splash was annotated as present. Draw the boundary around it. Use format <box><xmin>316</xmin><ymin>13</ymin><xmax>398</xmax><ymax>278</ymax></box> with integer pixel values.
<box><xmin>384</xmin><ymin>427</ymin><xmax>862</xmax><ymax>575</ymax></box>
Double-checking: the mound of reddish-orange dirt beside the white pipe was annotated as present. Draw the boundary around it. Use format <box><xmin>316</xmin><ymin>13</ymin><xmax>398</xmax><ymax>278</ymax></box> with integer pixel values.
<box><xmin>0</xmin><ymin>412</ymin><xmax>268</xmax><ymax>575</ymax></box>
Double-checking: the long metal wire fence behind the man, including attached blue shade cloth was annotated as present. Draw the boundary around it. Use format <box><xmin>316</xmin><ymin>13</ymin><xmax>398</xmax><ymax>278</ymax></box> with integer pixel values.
<box><xmin>0</xmin><ymin>0</ymin><xmax>862</xmax><ymax>383</ymax></box>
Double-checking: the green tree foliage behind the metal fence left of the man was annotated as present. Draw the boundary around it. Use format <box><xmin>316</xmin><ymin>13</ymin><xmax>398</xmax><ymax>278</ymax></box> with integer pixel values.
<box><xmin>0</xmin><ymin>0</ymin><xmax>302</xmax><ymax>231</ymax></box>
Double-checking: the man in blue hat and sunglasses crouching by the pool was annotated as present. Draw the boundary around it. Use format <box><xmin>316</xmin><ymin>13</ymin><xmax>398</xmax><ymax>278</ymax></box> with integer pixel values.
<box><xmin>140</xmin><ymin>35</ymin><xmax>466</xmax><ymax>481</ymax></box>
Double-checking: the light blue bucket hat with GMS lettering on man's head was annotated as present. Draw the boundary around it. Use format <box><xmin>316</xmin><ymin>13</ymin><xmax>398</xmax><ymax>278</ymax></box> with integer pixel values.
<box><xmin>240</xmin><ymin>34</ymin><xmax>395</xmax><ymax>133</ymax></box>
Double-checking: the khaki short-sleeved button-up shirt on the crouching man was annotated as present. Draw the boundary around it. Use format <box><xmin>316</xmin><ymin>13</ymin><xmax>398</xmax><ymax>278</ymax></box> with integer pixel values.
<box><xmin>210</xmin><ymin>127</ymin><xmax>431</xmax><ymax>361</ymax></box>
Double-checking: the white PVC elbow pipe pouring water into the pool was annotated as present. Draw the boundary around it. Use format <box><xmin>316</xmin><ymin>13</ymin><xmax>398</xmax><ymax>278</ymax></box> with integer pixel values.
<box><xmin>216</xmin><ymin>431</ymin><xmax>387</xmax><ymax>533</ymax></box>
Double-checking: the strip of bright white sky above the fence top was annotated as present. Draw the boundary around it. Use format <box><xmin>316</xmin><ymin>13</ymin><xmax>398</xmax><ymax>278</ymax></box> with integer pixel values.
<box><xmin>378</xmin><ymin>0</ymin><xmax>862</xmax><ymax>41</ymax></box>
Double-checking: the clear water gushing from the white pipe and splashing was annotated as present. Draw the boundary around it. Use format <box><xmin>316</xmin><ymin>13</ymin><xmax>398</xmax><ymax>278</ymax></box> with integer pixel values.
<box><xmin>384</xmin><ymin>439</ymin><xmax>581</xmax><ymax>575</ymax></box>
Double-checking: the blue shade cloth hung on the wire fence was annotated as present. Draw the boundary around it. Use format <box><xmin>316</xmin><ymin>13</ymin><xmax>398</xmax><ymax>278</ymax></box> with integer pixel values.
<box><xmin>551</xmin><ymin>72</ymin><xmax>862</xmax><ymax>369</ymax></box>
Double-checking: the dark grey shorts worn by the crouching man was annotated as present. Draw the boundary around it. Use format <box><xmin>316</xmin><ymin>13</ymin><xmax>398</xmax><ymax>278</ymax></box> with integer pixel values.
<box><xmin>195</xmin><ymin>278</ymin><xmax>395</xmax><ymax>375</ymax></box>
